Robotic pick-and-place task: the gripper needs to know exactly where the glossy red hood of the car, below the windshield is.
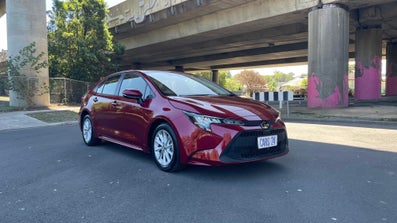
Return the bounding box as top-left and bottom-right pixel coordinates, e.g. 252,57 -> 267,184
170,96 -> 279,121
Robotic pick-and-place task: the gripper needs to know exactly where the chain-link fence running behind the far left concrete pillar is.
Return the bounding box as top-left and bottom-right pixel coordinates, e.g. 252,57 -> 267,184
0,74 -> 92,104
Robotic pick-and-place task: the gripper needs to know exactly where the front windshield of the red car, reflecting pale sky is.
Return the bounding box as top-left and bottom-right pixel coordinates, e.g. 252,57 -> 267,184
146,72 -> 233,96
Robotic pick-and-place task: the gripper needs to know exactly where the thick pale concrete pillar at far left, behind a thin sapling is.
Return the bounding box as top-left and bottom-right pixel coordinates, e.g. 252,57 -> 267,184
6,0 -> 50,107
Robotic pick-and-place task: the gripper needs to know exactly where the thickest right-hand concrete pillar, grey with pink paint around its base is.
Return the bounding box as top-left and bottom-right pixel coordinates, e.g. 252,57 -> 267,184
307,4 -> 349,108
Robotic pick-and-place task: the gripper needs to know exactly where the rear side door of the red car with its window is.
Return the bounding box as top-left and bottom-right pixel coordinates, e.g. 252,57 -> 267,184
92,74 -> 121,138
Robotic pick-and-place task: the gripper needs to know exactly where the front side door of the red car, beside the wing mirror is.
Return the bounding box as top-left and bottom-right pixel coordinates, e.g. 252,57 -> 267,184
115,72 -> 154,149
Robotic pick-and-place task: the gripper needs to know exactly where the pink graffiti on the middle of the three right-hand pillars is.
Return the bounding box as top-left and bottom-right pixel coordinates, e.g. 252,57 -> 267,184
354,56 -> 382,100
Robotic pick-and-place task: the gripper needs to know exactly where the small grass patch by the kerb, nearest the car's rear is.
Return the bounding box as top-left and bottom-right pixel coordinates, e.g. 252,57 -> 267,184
27,110 -> 79,123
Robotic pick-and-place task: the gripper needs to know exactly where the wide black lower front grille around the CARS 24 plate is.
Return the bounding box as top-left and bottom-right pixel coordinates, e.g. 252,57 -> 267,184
220,129 -> 288,163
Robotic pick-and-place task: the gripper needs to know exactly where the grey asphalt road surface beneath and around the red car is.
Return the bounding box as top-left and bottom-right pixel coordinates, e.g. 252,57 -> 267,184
0,123 -> 397,223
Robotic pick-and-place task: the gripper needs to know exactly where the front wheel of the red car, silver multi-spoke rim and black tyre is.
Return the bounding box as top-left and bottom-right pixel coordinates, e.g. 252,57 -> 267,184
152,123 -> 183,172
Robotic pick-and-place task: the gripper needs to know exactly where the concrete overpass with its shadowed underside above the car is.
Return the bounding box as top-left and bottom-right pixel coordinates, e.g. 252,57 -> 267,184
110,0 -> 397,70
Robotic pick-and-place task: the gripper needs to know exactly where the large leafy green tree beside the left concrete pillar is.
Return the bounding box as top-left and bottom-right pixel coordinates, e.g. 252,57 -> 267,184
48,0 -> 124,81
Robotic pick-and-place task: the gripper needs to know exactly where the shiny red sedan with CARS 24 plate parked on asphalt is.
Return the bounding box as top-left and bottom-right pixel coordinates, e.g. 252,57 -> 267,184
80,70 -> 288,171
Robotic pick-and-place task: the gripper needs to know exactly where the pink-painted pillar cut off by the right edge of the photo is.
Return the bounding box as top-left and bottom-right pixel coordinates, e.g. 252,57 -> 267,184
386,42 -> 397,96
